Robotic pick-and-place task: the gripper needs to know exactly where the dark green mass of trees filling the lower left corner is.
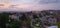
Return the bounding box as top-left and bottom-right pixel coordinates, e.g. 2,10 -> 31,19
0,13 -> 21,28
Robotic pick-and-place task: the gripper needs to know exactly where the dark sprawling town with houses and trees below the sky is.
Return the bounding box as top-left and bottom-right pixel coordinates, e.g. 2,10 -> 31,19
0,10 -> 60,28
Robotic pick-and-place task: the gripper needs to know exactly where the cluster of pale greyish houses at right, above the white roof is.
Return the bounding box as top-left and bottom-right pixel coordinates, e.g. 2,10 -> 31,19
40,16 -> 57,25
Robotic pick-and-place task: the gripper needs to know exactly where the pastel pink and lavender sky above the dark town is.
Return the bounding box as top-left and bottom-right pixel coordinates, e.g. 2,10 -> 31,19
0,0 -> 60,11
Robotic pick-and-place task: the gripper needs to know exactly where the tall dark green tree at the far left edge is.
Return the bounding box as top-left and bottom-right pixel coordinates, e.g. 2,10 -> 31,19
0,13 -> 9,28
